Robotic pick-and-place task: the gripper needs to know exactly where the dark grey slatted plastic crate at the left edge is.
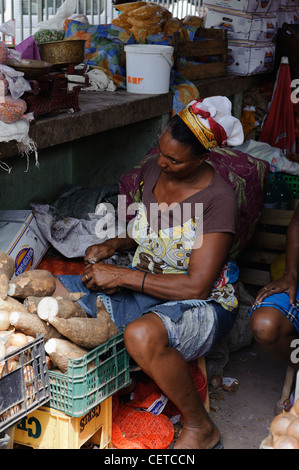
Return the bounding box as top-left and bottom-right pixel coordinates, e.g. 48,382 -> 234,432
0,335 -> 50,433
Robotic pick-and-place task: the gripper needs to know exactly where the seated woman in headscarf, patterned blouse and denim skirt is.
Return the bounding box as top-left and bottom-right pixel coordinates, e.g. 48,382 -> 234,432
56,97 -> 243,449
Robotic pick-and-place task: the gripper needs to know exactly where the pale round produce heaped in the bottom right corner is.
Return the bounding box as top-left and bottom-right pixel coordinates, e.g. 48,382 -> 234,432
260,399 -> 299,449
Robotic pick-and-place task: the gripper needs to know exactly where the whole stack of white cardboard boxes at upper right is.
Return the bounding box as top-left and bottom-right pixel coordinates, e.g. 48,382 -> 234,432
204,0 -> 279,75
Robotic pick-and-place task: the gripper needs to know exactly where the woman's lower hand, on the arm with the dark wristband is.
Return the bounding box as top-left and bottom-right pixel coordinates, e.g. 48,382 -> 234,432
81,262 -> 123,294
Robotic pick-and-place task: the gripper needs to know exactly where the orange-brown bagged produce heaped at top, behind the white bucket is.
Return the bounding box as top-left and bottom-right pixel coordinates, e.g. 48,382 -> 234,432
111,1 -> 202,43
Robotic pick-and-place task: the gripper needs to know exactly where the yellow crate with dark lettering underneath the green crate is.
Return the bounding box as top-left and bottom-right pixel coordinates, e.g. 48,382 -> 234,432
14,397 -> 112,449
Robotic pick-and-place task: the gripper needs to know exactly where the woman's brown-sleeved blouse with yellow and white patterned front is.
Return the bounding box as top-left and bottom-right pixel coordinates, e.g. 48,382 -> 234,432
131,158 -> 239,310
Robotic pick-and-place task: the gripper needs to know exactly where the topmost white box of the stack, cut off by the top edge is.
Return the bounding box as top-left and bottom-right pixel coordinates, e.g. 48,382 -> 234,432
203,0 -> 280,14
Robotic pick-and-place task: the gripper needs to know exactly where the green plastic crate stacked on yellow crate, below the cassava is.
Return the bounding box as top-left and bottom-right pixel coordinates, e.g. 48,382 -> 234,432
14,333 -> 131,449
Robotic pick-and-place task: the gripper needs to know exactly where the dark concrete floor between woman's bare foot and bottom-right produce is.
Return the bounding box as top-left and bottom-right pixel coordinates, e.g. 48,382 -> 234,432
209,341 -> 286,449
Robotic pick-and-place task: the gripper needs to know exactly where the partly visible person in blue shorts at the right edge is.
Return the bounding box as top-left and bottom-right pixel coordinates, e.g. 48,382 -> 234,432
251,206 -> 299,370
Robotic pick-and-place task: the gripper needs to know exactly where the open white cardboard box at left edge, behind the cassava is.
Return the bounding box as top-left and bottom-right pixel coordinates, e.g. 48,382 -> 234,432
0,210 -> 49,276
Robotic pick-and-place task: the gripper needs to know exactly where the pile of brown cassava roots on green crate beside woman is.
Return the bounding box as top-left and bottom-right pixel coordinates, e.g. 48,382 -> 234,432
0,251 -> 118,378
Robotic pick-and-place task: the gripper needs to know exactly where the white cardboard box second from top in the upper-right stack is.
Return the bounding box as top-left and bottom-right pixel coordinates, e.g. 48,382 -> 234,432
205,8 -> 278,43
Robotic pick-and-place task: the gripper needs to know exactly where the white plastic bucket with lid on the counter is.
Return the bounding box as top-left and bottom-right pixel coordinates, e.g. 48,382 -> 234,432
125,44 -> 173,95
